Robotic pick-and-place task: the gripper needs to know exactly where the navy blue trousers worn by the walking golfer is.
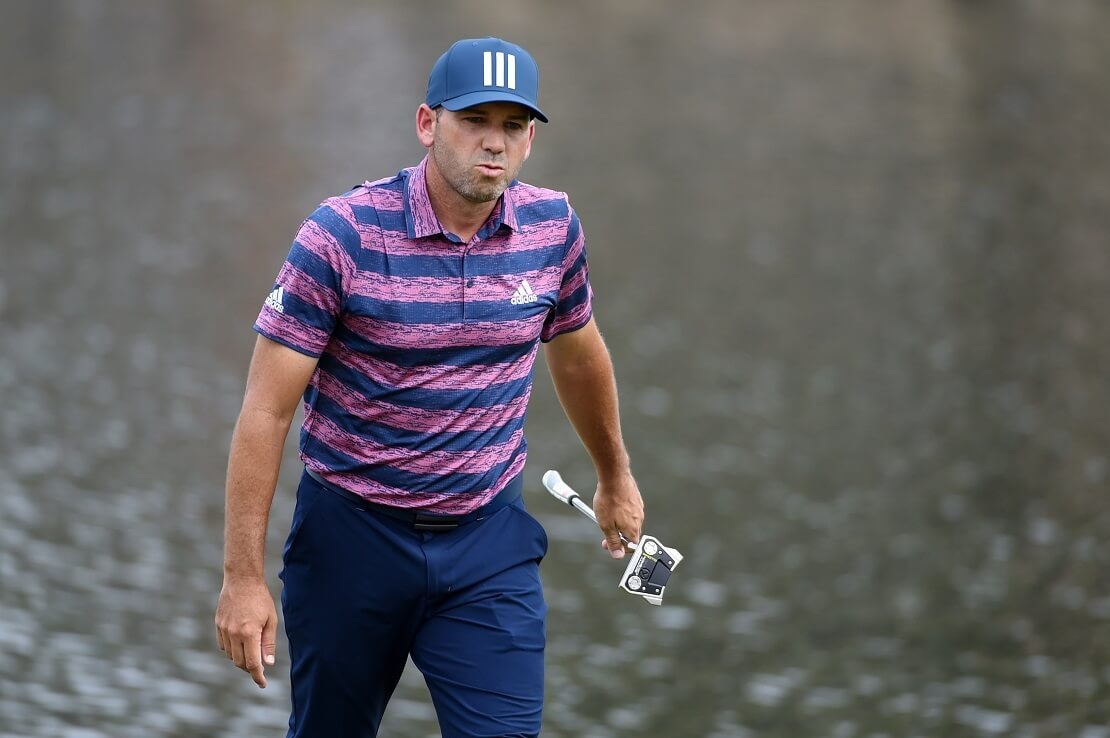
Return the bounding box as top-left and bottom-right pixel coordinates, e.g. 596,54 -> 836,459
281,474 -> 547,738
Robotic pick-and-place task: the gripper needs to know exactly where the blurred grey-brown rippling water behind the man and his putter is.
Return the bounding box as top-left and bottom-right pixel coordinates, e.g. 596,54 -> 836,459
0,0 -> 1110,738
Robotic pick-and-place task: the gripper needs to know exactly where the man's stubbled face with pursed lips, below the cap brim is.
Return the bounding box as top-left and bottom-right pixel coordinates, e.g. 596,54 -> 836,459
432,102 -> 535,203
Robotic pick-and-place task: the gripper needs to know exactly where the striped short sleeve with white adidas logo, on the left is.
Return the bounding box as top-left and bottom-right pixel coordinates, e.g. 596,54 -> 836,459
254,199 -> 361,357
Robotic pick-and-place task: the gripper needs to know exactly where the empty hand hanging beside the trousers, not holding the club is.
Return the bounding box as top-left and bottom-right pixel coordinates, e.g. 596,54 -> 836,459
215,577 -> 278,688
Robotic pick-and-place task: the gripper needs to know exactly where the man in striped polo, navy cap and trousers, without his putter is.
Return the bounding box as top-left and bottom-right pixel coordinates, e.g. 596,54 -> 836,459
215,38 -> 644,738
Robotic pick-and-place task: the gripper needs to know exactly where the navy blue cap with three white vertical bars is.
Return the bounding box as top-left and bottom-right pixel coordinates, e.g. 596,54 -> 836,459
424,38 -> 547,123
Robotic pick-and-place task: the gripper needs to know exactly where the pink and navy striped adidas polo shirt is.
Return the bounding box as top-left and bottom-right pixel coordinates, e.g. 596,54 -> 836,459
254,158 -> 592,514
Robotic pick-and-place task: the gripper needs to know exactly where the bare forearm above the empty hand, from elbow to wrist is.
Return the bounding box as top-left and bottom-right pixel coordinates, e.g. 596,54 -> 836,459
223,407 -> 291,578
